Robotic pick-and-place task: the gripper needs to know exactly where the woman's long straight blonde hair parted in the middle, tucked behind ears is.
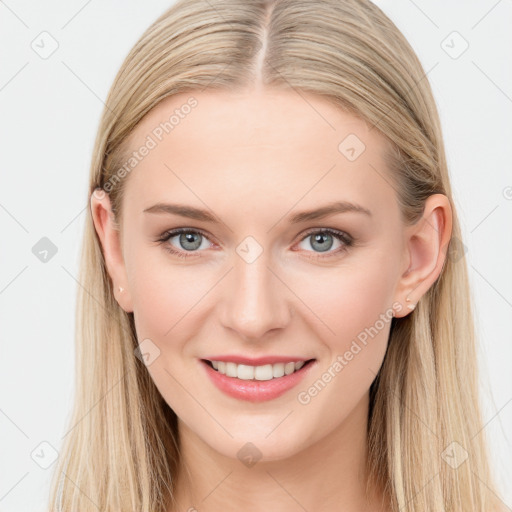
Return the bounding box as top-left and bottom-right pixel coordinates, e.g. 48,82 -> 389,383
50,0 -> 499,512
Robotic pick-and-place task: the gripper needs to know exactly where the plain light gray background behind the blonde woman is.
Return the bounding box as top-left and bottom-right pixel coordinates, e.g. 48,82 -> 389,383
0,0 -> 512,512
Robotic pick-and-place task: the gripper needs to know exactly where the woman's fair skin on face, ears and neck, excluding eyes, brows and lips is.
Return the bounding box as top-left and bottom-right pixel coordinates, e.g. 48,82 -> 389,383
91,89 -> 452,512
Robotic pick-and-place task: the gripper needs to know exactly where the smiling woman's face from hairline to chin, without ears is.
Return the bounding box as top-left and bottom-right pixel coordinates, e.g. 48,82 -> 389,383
93,91 -> 409,460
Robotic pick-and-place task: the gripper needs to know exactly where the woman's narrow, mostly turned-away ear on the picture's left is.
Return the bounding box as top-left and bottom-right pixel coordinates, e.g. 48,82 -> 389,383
91,188 -> 133,313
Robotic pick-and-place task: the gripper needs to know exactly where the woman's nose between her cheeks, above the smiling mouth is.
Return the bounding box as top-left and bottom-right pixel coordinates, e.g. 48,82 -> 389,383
220,252 -> 293,341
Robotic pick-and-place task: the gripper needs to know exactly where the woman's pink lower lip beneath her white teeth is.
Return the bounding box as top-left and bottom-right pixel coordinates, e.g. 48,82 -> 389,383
199,360 -> 316,402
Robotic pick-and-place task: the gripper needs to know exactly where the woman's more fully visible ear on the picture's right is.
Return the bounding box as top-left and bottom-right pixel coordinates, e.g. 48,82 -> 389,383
395,194 -> 452,318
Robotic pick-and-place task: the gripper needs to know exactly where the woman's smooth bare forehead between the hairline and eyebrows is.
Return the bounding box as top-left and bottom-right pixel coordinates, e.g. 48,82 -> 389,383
121,90 -> 397,225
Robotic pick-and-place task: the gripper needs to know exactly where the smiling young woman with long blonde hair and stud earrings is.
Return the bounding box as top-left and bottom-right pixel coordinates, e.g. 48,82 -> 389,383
47,0 -> 504,512
